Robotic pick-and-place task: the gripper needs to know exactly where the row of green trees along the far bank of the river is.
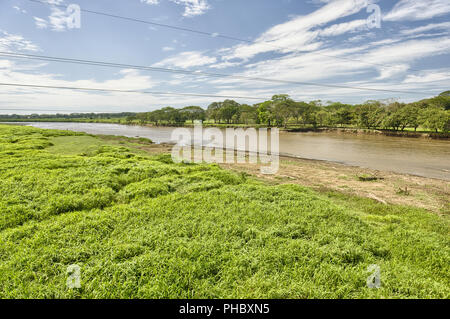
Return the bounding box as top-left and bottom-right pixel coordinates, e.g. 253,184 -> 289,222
0,91 -> 450,132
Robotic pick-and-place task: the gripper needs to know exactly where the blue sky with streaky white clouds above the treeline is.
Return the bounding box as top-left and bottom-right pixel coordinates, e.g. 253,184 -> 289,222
0,0 -> 450,114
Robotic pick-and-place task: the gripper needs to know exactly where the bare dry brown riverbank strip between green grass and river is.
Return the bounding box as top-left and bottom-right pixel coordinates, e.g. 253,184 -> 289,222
107,136 -> 450,216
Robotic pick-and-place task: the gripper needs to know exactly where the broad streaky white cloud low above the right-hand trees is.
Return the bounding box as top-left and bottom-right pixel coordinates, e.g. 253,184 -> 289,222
211,37 -> 450,99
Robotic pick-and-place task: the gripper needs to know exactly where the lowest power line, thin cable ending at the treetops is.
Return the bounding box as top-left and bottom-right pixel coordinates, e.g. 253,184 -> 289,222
0,83 -> 266,100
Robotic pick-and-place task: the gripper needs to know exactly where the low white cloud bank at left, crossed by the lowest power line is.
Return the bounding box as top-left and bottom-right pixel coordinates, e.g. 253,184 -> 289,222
0,60 -> 188,113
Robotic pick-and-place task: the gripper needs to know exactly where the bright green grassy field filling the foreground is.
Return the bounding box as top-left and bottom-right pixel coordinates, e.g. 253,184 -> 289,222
0,125 -> 450,298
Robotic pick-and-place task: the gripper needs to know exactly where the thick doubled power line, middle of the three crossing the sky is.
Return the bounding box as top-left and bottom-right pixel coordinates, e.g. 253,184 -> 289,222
0,51 -> 436,95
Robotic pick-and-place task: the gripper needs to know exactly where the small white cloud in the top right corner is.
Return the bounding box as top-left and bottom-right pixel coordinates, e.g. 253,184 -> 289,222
383,0 -> 450,21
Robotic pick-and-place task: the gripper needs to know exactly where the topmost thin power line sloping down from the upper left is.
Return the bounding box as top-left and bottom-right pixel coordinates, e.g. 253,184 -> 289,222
28,0 -> 428,72
